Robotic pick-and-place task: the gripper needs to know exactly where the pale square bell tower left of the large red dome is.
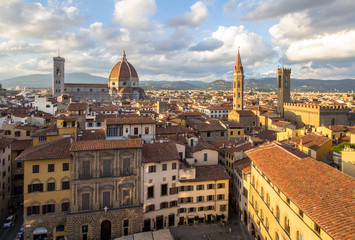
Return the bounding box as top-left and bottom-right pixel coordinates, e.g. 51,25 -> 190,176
52,56 -> 65,97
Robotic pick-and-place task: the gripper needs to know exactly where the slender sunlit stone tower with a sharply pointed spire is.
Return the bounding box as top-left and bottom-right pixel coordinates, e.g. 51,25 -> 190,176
233,49 -> 244,110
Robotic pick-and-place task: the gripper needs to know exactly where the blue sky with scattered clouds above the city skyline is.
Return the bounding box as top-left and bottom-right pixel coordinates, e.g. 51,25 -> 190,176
0,0 -> 355,81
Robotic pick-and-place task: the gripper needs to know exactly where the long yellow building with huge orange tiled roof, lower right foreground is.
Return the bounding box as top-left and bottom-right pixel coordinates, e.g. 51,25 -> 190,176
246,142 -> 355,240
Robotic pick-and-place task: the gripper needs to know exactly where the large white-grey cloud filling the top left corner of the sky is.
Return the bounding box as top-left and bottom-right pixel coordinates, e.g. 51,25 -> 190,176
0,0 -> 85,39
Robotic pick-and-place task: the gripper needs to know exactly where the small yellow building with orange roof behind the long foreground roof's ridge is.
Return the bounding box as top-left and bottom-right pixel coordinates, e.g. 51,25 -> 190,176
291,133 -> 332,161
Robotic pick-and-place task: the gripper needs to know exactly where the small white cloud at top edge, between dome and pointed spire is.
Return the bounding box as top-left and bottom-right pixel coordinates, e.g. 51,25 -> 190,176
169,1 -> 208,27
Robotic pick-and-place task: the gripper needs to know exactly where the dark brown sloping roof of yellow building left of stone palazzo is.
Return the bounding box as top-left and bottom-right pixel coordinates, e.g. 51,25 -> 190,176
16,138 -> 71,161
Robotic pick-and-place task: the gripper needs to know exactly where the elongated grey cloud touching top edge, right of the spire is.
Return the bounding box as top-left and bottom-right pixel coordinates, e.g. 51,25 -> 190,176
244,0 -> 334,21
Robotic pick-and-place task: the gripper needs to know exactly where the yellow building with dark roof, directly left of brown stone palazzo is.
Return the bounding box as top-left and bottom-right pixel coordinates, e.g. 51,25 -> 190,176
16,138 -> 70,240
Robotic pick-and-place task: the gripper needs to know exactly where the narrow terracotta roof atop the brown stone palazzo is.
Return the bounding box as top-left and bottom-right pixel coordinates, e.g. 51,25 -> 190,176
70,138 -> 143,152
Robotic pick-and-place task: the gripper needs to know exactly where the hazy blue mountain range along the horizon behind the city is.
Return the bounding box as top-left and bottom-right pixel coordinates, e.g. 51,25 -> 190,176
0,73 -> 355,92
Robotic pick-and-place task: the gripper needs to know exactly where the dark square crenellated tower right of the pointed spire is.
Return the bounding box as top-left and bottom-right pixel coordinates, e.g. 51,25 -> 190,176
276,67 -> 291,117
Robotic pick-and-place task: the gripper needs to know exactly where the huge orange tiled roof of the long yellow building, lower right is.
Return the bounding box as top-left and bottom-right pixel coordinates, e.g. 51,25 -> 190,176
246,142 -> 355,240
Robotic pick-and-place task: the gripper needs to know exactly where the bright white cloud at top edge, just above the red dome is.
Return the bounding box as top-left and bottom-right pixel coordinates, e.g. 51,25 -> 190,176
113,0 -> 157,28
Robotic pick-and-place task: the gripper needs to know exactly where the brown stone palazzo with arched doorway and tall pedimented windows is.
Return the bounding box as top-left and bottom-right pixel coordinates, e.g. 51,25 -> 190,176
67,139 -> 143,240
